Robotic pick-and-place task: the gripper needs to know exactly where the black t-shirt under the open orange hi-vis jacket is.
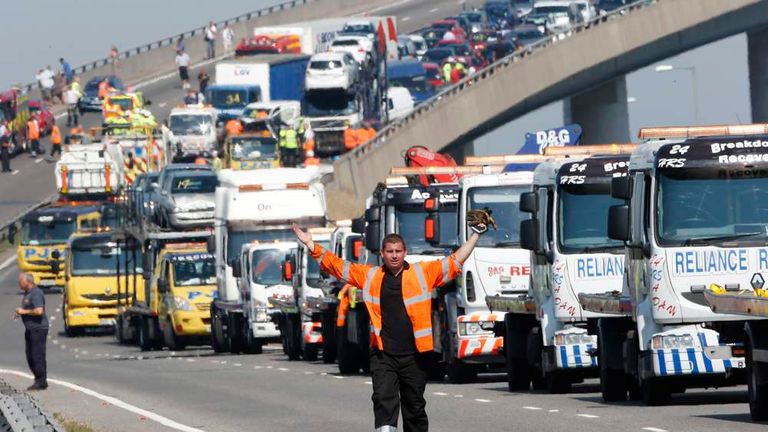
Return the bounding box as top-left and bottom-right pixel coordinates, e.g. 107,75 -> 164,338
380,263 -> 416,355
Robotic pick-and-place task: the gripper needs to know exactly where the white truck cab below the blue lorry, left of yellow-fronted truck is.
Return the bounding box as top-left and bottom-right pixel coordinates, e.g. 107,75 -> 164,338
165,105 -> 218,161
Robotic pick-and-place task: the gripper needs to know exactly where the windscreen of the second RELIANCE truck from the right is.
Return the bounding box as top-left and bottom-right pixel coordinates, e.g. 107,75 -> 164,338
557,181 -> 622,253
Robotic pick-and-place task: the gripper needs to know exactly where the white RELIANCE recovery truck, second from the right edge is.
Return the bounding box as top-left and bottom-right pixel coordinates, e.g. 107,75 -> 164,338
504,146 -> 629,393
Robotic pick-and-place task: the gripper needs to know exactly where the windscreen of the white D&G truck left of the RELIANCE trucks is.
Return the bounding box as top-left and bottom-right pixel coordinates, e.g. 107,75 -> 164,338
467,186 -> 530,247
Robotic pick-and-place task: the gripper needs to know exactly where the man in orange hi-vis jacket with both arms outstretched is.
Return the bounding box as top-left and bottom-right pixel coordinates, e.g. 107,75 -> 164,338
293,224 -> 488,432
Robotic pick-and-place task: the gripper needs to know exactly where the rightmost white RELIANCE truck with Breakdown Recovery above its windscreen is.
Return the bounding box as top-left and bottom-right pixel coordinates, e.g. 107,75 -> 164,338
583,125 -> 768,405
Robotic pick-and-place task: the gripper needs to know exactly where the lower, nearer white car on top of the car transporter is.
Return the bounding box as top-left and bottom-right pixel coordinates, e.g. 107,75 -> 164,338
304,52 -> 358,90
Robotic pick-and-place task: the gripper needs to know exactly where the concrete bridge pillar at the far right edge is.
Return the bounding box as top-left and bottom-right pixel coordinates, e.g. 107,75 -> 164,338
747,27 -> 768,123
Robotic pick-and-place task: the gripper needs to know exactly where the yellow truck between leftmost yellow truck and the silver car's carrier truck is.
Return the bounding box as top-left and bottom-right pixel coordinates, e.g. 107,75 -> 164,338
61,232 -> 144,337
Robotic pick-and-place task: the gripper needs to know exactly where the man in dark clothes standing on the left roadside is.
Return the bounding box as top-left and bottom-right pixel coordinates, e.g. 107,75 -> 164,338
14,273 -> 48,390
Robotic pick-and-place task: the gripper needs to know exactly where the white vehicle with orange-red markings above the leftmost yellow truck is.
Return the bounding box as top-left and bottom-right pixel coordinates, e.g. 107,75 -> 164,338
54,143 -> 125,197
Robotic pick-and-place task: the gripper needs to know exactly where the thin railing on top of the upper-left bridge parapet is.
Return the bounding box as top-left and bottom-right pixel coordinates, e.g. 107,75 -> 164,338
15,0 -> 318,92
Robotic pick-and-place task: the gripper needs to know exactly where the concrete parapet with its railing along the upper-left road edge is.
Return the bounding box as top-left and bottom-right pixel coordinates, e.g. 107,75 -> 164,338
19,0 -> 391,97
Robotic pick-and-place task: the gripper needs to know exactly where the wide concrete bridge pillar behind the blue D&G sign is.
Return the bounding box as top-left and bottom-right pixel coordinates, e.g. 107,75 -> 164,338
563,76 -> 630,144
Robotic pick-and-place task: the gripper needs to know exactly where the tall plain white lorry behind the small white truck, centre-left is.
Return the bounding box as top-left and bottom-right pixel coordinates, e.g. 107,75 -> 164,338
209,167 -> 326,352
